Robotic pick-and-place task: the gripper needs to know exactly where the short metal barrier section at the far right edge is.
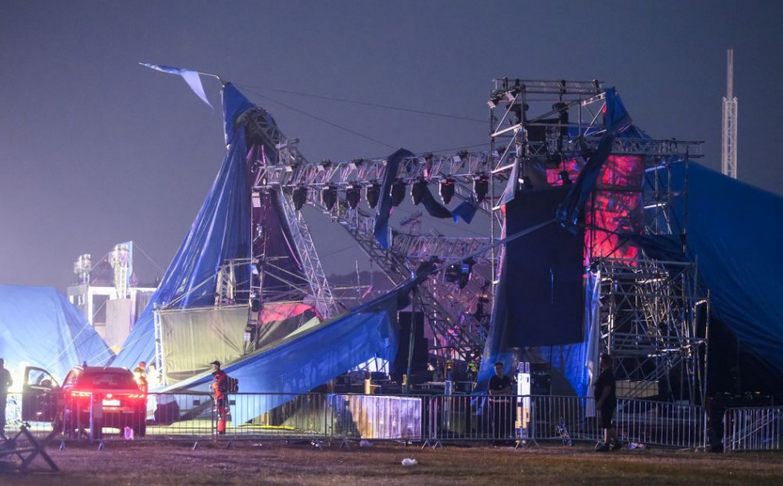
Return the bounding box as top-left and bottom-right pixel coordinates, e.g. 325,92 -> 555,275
723,407 -> 783,452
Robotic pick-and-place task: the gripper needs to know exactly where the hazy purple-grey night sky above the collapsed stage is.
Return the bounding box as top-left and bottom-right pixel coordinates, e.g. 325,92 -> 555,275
0,0 -> 783,292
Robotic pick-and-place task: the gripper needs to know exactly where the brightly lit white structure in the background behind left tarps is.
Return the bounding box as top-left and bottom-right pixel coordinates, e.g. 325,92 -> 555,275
68,241 -> 155,351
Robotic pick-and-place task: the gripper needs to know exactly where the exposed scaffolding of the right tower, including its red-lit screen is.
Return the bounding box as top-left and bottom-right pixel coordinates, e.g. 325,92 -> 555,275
488,78 -> 708,403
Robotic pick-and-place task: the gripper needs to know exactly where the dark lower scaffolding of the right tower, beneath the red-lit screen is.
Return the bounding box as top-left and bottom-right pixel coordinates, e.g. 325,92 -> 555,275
594,259 -> 707,403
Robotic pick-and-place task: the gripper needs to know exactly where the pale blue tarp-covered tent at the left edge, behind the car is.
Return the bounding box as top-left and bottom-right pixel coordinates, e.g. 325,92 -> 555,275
0,285 -> 113,385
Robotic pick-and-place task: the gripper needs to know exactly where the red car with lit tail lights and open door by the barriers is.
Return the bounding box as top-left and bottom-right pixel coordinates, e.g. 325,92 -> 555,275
22,366 -> 147,437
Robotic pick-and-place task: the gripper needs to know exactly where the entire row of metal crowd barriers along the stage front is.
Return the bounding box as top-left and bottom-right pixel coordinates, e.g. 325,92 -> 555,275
6,392 -> 712,450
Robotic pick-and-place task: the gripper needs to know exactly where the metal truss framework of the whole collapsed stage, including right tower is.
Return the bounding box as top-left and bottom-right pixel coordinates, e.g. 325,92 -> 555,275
233,78 -> 703,380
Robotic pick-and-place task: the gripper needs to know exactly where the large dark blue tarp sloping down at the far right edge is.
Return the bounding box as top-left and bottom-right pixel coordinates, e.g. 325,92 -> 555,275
643,161 -> 783,372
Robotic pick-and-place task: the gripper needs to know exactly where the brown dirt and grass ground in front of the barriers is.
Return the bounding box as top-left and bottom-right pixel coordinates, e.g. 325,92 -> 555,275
0,441 -> 783,486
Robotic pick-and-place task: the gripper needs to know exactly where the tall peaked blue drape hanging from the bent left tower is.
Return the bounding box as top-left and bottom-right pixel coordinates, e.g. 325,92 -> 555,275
114,84 -> 304,372
